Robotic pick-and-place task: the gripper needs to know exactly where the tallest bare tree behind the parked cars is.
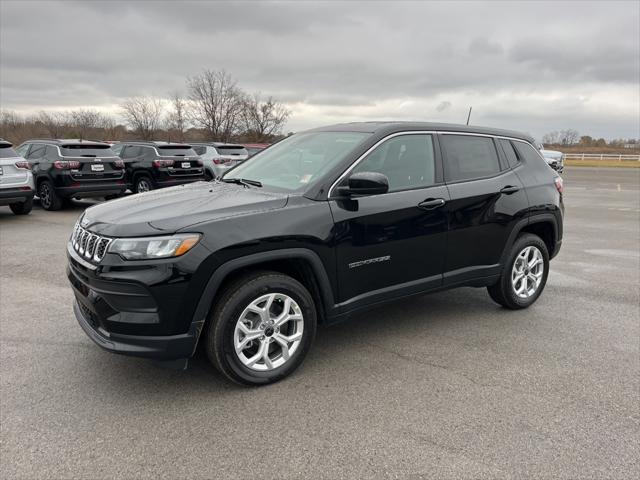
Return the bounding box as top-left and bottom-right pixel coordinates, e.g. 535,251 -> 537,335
187,70 -> 244,142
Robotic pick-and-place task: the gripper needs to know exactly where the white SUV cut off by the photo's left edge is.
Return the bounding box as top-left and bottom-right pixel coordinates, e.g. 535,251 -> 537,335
0,139 -> 35,215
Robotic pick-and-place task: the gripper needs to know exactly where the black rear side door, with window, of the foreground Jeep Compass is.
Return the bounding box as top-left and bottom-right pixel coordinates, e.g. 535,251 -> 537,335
440,134 -> 528,285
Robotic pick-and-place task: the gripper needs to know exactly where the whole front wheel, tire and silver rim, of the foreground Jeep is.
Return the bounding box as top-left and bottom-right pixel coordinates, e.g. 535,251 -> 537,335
205,272 -> 316,385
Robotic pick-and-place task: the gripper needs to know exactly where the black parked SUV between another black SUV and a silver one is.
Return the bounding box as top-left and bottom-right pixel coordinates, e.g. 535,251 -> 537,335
113,142 -> 204,193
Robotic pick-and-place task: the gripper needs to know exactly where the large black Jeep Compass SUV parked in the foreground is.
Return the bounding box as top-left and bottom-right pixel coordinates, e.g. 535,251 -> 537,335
67,123 -> 564,384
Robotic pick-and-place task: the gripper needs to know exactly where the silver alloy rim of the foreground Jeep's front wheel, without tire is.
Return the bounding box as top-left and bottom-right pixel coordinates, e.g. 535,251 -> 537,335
233,293 -> 304,372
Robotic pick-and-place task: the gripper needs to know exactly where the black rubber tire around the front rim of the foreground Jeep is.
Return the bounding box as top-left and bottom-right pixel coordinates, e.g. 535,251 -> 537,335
204,271 -> 317,386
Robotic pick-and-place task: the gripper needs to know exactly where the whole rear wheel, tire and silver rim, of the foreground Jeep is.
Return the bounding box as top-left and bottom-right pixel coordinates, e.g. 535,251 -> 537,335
487,233 -> 549,310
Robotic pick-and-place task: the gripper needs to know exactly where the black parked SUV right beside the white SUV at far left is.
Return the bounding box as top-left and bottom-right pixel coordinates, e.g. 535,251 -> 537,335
16,140 -> 127,210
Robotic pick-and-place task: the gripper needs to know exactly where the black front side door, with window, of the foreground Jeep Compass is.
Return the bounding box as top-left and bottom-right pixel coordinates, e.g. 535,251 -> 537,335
330,134 -> 449,308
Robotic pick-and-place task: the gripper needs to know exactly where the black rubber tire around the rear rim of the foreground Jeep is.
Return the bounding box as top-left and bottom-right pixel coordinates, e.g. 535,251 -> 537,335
487,233 -> 549,310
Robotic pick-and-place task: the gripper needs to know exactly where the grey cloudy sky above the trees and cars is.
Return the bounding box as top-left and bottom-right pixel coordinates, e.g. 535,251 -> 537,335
0,0 -> 640,138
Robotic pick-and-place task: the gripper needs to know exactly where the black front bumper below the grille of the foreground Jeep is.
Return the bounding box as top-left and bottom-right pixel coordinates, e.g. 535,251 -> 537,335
67,244 -> 204,360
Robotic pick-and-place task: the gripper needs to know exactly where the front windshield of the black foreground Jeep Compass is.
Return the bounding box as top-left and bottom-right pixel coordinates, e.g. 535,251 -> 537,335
223,132 -> 371,191
